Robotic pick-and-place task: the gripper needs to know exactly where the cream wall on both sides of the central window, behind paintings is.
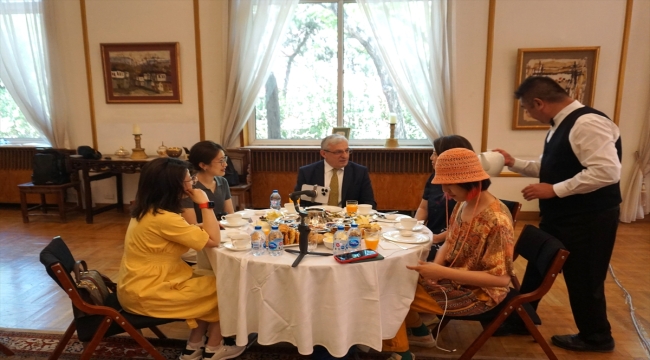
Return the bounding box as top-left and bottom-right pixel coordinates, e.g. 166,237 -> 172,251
57,0 -> 650,211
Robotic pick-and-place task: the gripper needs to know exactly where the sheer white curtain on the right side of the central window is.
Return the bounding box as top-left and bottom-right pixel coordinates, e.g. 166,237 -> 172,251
357,0 -> 454,141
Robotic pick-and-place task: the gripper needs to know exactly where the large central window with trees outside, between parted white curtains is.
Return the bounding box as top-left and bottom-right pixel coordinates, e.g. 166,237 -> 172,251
251,0 -> 428,144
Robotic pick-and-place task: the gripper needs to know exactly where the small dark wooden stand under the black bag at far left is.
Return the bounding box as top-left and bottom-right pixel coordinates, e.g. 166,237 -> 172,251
18,181 -> 82,223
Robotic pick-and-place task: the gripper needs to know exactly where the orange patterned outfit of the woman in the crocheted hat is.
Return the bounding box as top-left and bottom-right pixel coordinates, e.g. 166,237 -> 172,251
420,199 -> 514,316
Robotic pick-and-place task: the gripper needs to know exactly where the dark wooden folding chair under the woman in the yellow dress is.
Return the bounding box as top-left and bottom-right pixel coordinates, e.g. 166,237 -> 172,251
40,236 -> 180,360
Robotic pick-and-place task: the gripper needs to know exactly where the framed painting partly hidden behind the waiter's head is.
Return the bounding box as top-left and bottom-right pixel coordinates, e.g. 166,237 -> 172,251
512,46 -> 600,130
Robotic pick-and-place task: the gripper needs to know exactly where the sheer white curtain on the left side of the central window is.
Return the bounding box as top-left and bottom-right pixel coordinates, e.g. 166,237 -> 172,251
221,0 -> 299,147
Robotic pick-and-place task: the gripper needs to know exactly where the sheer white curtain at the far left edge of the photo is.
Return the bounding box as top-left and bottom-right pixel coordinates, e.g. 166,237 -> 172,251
0,0 -> 69,148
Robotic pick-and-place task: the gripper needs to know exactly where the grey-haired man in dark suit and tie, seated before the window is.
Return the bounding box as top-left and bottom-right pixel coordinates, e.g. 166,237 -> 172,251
294,134 -> 377,209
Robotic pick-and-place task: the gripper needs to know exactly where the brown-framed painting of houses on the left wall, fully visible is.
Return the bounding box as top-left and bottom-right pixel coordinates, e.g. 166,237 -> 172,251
100,42 -> 182,103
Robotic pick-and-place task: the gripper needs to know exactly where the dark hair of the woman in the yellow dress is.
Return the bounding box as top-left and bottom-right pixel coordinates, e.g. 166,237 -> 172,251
131,158 -> 190,221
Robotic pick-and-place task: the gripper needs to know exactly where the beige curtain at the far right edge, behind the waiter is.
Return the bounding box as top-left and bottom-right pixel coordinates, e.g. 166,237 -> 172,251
620,104 -> 650,223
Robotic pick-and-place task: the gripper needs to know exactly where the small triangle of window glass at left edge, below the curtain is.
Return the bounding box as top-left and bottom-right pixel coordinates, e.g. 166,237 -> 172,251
0,80 -> 43,144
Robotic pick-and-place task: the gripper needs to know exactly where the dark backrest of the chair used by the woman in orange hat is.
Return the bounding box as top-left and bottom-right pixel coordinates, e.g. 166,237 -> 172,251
515,224 -> 569,299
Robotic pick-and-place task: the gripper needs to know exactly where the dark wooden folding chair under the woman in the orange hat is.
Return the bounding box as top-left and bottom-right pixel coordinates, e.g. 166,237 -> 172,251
432,225 -> 569,360
